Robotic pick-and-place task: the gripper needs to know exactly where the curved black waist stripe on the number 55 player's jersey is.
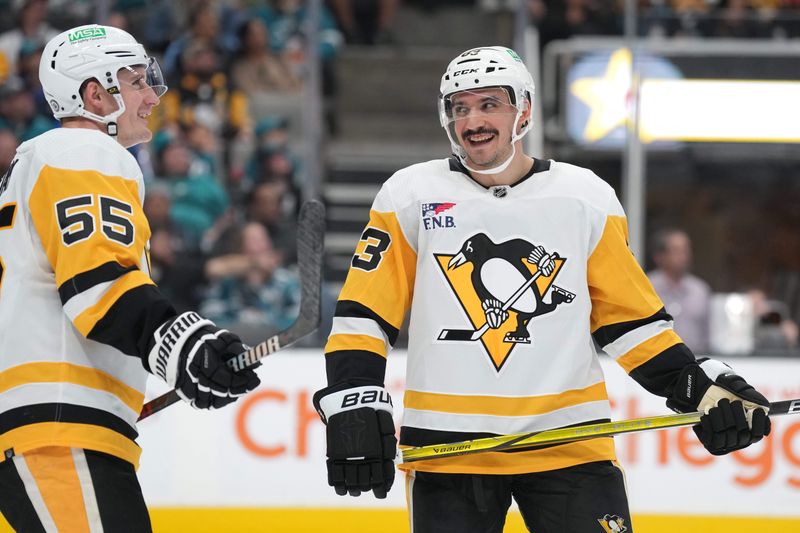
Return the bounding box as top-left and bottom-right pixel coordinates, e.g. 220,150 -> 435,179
0,403 -> 139,441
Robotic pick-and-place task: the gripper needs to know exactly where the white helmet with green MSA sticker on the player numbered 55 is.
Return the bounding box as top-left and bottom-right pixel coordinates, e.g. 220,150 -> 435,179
39,24 -> 167,135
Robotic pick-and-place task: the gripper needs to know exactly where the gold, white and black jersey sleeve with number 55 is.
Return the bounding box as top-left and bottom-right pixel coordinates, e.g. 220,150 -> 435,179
28,165 -> 175,356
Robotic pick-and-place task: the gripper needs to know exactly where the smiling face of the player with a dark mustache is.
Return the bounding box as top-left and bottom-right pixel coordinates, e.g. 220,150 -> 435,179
450,87 -> 517,169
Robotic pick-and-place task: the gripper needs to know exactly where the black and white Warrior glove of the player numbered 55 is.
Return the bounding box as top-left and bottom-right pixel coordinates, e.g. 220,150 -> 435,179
145,312 -> 261,409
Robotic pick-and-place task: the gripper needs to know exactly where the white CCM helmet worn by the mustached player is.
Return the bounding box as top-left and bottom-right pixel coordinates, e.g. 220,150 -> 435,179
439,46 -> 535,174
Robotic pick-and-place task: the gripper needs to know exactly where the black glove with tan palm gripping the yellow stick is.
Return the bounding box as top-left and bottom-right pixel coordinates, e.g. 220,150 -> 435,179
667,358 -> 771,455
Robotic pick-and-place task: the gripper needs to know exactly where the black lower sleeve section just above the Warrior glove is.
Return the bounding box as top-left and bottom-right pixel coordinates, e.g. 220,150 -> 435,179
88,285 -> 178,360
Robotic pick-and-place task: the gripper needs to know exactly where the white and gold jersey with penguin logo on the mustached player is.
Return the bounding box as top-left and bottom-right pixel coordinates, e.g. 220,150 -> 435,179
325,159 -> 694,474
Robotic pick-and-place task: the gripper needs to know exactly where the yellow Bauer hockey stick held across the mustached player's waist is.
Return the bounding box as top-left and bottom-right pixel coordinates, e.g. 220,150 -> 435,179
402,398 -> 800,463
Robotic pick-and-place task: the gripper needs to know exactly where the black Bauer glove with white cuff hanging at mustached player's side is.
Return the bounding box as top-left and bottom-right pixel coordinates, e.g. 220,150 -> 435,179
314,380 -> 397,498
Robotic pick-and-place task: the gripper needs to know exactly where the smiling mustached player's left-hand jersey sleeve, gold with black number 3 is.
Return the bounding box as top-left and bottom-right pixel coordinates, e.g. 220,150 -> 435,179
325,182 -> 417,384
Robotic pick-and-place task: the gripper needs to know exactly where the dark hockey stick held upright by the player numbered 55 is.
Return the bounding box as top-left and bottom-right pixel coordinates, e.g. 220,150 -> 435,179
139,200 -> 325,420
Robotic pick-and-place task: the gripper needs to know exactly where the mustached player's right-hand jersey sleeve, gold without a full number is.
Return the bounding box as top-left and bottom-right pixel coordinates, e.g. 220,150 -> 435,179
587,193 -> 695,396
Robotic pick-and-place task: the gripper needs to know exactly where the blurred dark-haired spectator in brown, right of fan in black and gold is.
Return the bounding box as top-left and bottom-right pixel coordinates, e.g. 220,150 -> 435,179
231,18 -> 302,95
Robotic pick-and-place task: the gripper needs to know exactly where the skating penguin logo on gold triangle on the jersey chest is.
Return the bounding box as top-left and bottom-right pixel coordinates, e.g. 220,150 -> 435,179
434,233 -> 575,371
